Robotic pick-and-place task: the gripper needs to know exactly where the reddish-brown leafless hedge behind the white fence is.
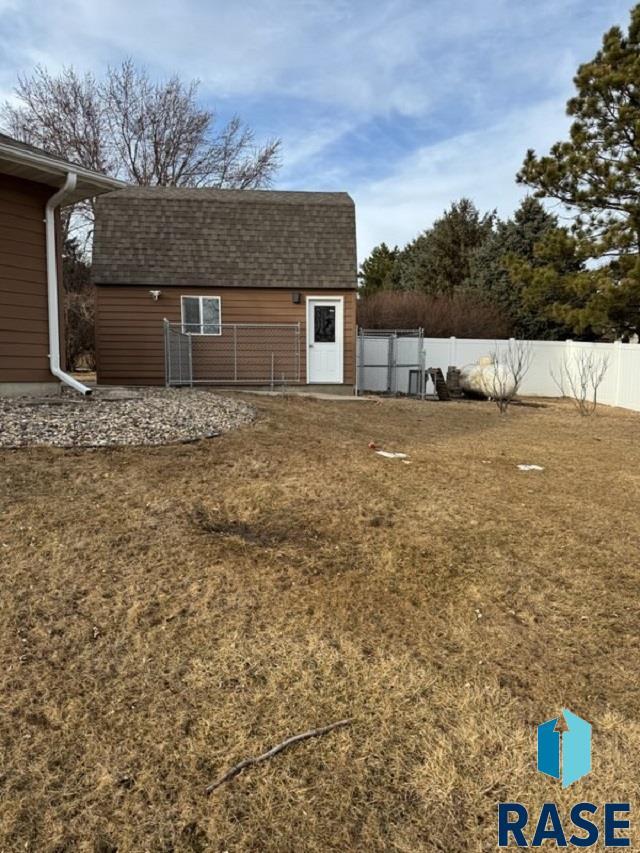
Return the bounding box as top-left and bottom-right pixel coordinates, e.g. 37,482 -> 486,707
358,290 -> 512,339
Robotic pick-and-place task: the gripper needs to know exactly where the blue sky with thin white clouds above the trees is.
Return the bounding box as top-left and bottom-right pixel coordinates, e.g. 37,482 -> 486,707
0,0 -> 632,258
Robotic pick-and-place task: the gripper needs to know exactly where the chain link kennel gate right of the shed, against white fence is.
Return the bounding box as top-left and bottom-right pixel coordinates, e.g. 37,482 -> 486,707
356,328 -> 426,398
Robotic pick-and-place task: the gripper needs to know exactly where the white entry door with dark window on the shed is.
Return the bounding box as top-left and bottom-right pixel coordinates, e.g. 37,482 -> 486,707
307,296 -> 344,383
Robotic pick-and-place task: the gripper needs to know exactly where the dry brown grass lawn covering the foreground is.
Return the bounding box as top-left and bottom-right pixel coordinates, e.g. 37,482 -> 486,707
0,399 -> 640,853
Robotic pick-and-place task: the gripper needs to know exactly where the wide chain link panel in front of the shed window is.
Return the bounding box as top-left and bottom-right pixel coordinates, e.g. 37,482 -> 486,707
164,320 -> 301,388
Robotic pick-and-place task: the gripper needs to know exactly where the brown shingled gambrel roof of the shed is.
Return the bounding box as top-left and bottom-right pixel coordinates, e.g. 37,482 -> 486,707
93,187 -> 356,289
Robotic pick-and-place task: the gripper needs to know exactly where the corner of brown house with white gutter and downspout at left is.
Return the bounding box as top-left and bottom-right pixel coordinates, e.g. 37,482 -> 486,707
0,134 -> 123,394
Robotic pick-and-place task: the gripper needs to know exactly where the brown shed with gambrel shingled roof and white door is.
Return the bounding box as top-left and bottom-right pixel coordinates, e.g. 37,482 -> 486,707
92,187 -> 357,387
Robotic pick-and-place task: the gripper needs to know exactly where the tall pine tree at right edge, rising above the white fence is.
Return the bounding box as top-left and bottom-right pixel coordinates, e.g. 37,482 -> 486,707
518,4 -> 640,337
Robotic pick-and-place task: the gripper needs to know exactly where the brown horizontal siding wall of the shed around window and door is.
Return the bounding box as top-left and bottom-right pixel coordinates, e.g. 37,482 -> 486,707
96,285 -> 356,385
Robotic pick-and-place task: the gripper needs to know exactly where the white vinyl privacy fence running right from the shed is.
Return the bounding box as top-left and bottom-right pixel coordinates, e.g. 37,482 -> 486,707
358,337 -> 640,411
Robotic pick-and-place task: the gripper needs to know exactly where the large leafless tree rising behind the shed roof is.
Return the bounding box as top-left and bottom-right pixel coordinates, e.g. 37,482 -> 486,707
0,59 -> 280,195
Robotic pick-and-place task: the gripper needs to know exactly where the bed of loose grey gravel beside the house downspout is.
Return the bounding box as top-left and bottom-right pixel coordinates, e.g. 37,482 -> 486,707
0,388 -> 255,448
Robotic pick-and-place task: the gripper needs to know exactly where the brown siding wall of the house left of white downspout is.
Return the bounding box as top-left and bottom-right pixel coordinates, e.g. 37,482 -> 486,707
0,175 -> 62,385
